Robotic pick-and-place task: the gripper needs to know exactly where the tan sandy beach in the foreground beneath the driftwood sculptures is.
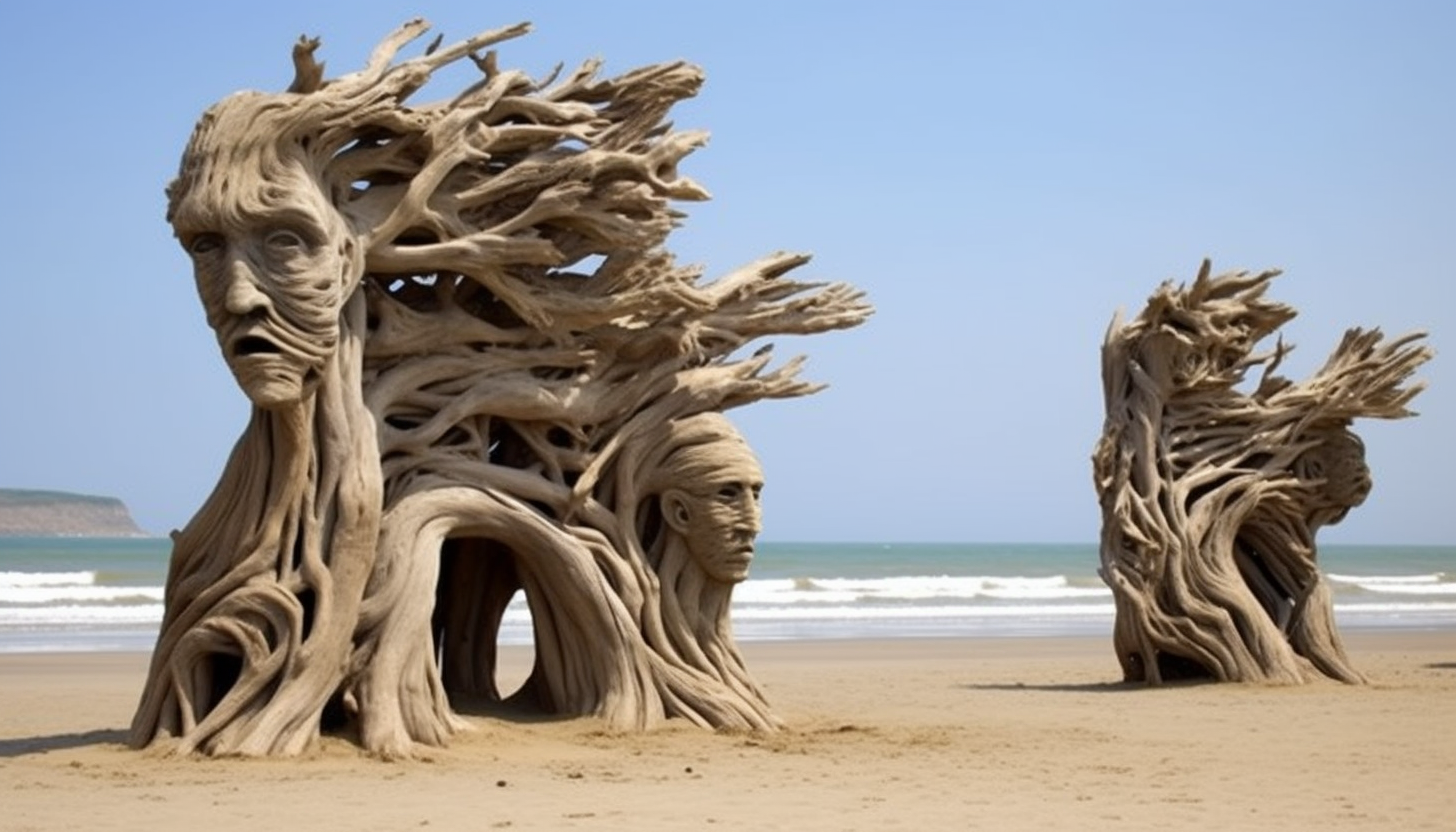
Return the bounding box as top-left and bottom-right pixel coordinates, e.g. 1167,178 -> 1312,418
0,631 -> 1456,832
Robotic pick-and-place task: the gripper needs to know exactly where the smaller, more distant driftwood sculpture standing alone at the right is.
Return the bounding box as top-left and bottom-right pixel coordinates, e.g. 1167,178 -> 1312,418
1093,261 -> 1431,683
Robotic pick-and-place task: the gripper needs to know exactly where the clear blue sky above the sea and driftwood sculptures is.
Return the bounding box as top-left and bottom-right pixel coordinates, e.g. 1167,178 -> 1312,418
0,0 -> 1456,543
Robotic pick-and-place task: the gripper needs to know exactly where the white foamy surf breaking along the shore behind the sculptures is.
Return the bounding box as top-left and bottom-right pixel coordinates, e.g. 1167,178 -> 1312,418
0,562 -> 1456,651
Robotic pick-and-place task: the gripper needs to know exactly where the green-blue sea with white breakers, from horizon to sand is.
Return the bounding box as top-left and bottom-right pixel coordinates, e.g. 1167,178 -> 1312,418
0,538 -> 1456,653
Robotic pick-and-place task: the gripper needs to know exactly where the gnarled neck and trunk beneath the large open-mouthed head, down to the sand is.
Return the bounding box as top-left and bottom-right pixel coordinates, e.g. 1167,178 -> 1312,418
132,292 -> 381,755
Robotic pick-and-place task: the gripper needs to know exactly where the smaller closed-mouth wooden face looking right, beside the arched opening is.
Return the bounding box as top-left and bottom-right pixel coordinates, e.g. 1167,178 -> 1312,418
660,412 -> 763,583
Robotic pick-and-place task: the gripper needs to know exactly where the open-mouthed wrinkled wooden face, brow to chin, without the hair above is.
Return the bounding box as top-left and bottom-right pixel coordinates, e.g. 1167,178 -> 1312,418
172,168 -> 357,408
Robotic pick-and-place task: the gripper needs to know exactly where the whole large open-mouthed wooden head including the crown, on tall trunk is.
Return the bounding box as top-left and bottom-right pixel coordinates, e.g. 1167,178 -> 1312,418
169,95 -> 363,408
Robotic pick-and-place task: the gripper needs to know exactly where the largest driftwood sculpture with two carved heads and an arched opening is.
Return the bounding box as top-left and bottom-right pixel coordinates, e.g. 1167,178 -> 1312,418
131,20 -> 871,756
